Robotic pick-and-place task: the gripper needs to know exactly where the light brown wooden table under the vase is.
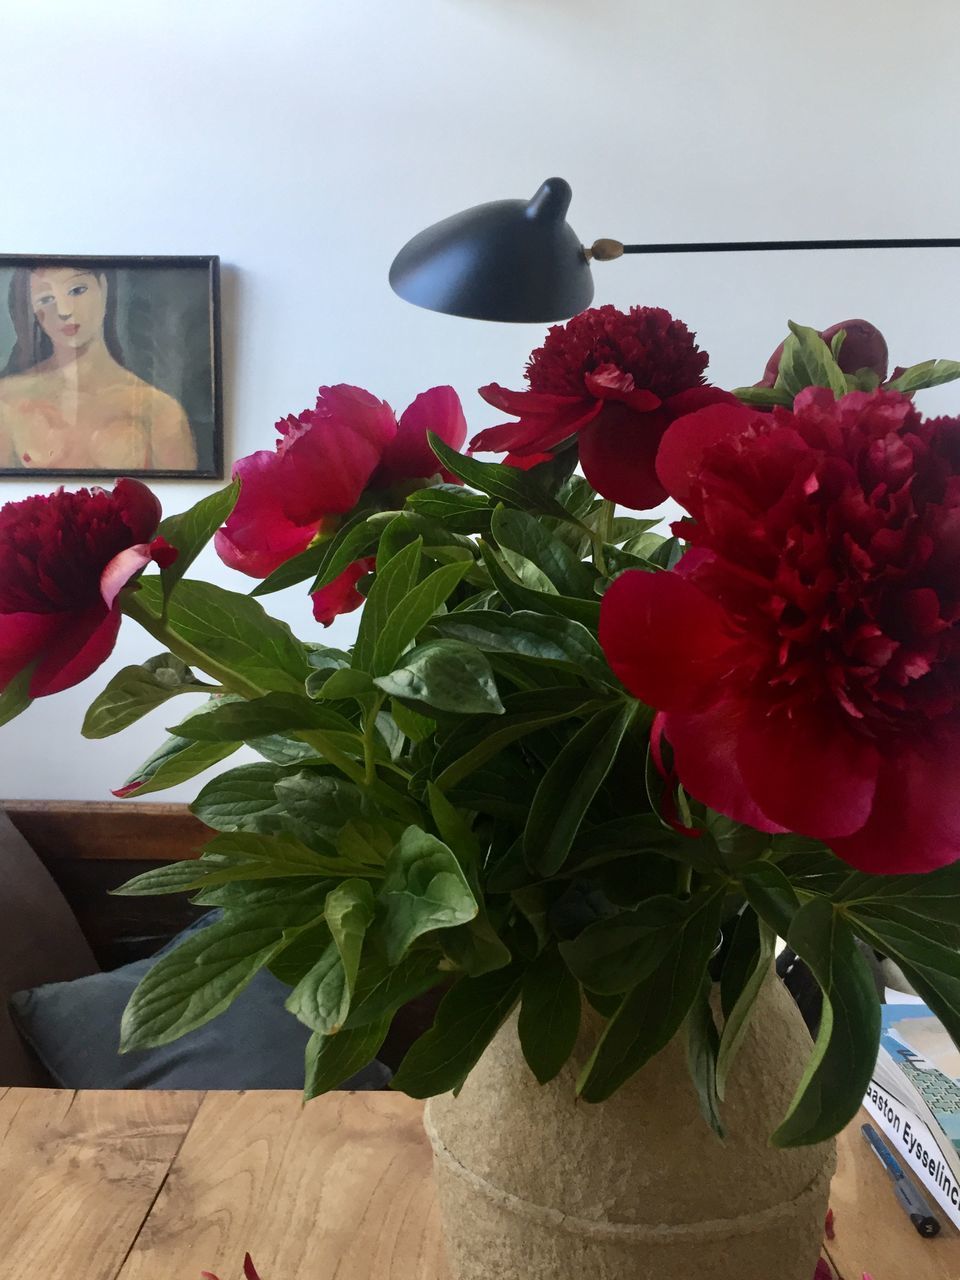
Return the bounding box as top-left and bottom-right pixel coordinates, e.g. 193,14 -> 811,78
0,1088 -> 960,1280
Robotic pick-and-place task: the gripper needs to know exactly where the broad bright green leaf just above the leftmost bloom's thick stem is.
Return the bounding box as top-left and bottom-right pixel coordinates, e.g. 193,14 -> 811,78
137,577 -> 310,694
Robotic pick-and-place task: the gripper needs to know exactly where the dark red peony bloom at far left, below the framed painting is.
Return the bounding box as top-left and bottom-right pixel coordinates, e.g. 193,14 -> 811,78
0,480 -> 177,698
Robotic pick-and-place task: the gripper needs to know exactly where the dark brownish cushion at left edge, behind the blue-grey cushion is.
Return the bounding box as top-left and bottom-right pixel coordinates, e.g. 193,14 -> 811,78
0,810 -> 97,1088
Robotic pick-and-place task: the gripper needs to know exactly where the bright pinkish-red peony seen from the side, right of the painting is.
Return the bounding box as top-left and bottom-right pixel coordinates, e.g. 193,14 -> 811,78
221,385 -> 467,577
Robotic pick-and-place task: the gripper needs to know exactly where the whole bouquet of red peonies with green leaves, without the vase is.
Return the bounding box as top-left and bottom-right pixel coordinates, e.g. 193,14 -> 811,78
0,307 -> 960,1146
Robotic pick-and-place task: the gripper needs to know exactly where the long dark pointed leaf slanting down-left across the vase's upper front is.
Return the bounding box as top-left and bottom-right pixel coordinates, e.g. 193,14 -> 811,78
577,892 -> 722,1102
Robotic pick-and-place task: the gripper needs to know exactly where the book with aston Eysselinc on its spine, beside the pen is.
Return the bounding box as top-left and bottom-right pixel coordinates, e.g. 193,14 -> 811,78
864,1002 -> 960,1228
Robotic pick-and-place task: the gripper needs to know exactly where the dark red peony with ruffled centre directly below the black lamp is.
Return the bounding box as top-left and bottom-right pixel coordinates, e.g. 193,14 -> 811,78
470,306 -> 737,511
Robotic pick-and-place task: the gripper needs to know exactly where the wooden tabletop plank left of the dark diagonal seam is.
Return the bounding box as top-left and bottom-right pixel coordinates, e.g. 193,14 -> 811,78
0,1088 -> 202,1280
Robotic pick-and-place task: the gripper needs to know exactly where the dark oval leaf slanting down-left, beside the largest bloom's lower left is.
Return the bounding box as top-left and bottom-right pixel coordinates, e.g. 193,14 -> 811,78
524,703 -> 639,876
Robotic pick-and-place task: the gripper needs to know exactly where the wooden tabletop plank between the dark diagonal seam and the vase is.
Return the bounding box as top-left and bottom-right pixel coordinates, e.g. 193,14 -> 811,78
118,1093 -> 445,1280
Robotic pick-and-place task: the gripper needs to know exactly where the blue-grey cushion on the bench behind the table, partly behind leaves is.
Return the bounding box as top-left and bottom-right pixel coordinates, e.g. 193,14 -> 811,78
10,911 -> 390,1089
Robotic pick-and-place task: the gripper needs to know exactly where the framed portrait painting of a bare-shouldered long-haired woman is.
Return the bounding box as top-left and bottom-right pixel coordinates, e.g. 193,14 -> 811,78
0,255 -> 223,479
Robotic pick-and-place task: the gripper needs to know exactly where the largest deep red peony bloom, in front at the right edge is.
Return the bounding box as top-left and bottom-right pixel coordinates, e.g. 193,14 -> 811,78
600,388 -> 960,872
